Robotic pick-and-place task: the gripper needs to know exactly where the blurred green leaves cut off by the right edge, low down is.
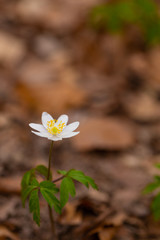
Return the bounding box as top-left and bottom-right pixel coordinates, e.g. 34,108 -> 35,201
143,163 -> 160,220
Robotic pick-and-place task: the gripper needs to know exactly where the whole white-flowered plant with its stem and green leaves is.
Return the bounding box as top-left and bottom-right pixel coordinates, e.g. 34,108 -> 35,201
21,112 -> 98,231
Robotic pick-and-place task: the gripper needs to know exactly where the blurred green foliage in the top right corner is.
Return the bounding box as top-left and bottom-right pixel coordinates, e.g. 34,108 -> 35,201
90,0 -> 160,44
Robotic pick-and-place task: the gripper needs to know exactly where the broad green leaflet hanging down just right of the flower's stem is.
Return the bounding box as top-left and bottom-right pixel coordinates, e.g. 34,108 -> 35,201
60,177 -> 76,207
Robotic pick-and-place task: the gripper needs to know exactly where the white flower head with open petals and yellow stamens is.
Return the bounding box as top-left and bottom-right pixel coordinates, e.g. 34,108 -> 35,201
29,112 -> 79,141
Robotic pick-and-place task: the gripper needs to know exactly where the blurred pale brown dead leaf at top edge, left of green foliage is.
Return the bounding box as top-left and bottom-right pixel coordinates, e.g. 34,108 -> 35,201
16,0 -> 101,33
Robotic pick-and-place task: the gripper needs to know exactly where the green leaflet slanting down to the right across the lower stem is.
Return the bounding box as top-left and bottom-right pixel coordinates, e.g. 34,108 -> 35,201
40,188 -> 61,213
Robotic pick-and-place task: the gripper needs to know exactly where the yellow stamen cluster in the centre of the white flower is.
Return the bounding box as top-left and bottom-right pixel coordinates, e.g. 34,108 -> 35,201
47,120 -> 65,135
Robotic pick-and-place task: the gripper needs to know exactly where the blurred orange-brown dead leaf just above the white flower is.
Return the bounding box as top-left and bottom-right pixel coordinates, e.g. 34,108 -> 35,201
17,82 -> 86,115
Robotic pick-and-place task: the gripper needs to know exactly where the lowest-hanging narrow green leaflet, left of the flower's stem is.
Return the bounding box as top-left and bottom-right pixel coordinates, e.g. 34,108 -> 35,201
29,189 -> 40,226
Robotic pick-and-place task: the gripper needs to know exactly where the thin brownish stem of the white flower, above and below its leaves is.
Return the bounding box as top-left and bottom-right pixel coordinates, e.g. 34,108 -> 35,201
47,141 -> 57,240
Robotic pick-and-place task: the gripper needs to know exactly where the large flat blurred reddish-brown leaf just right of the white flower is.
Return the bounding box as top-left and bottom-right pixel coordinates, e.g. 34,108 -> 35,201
73,117 -> 135,151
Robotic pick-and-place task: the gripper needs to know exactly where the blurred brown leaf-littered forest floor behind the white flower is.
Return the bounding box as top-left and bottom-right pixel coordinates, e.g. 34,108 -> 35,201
0,0 -> 160,240
